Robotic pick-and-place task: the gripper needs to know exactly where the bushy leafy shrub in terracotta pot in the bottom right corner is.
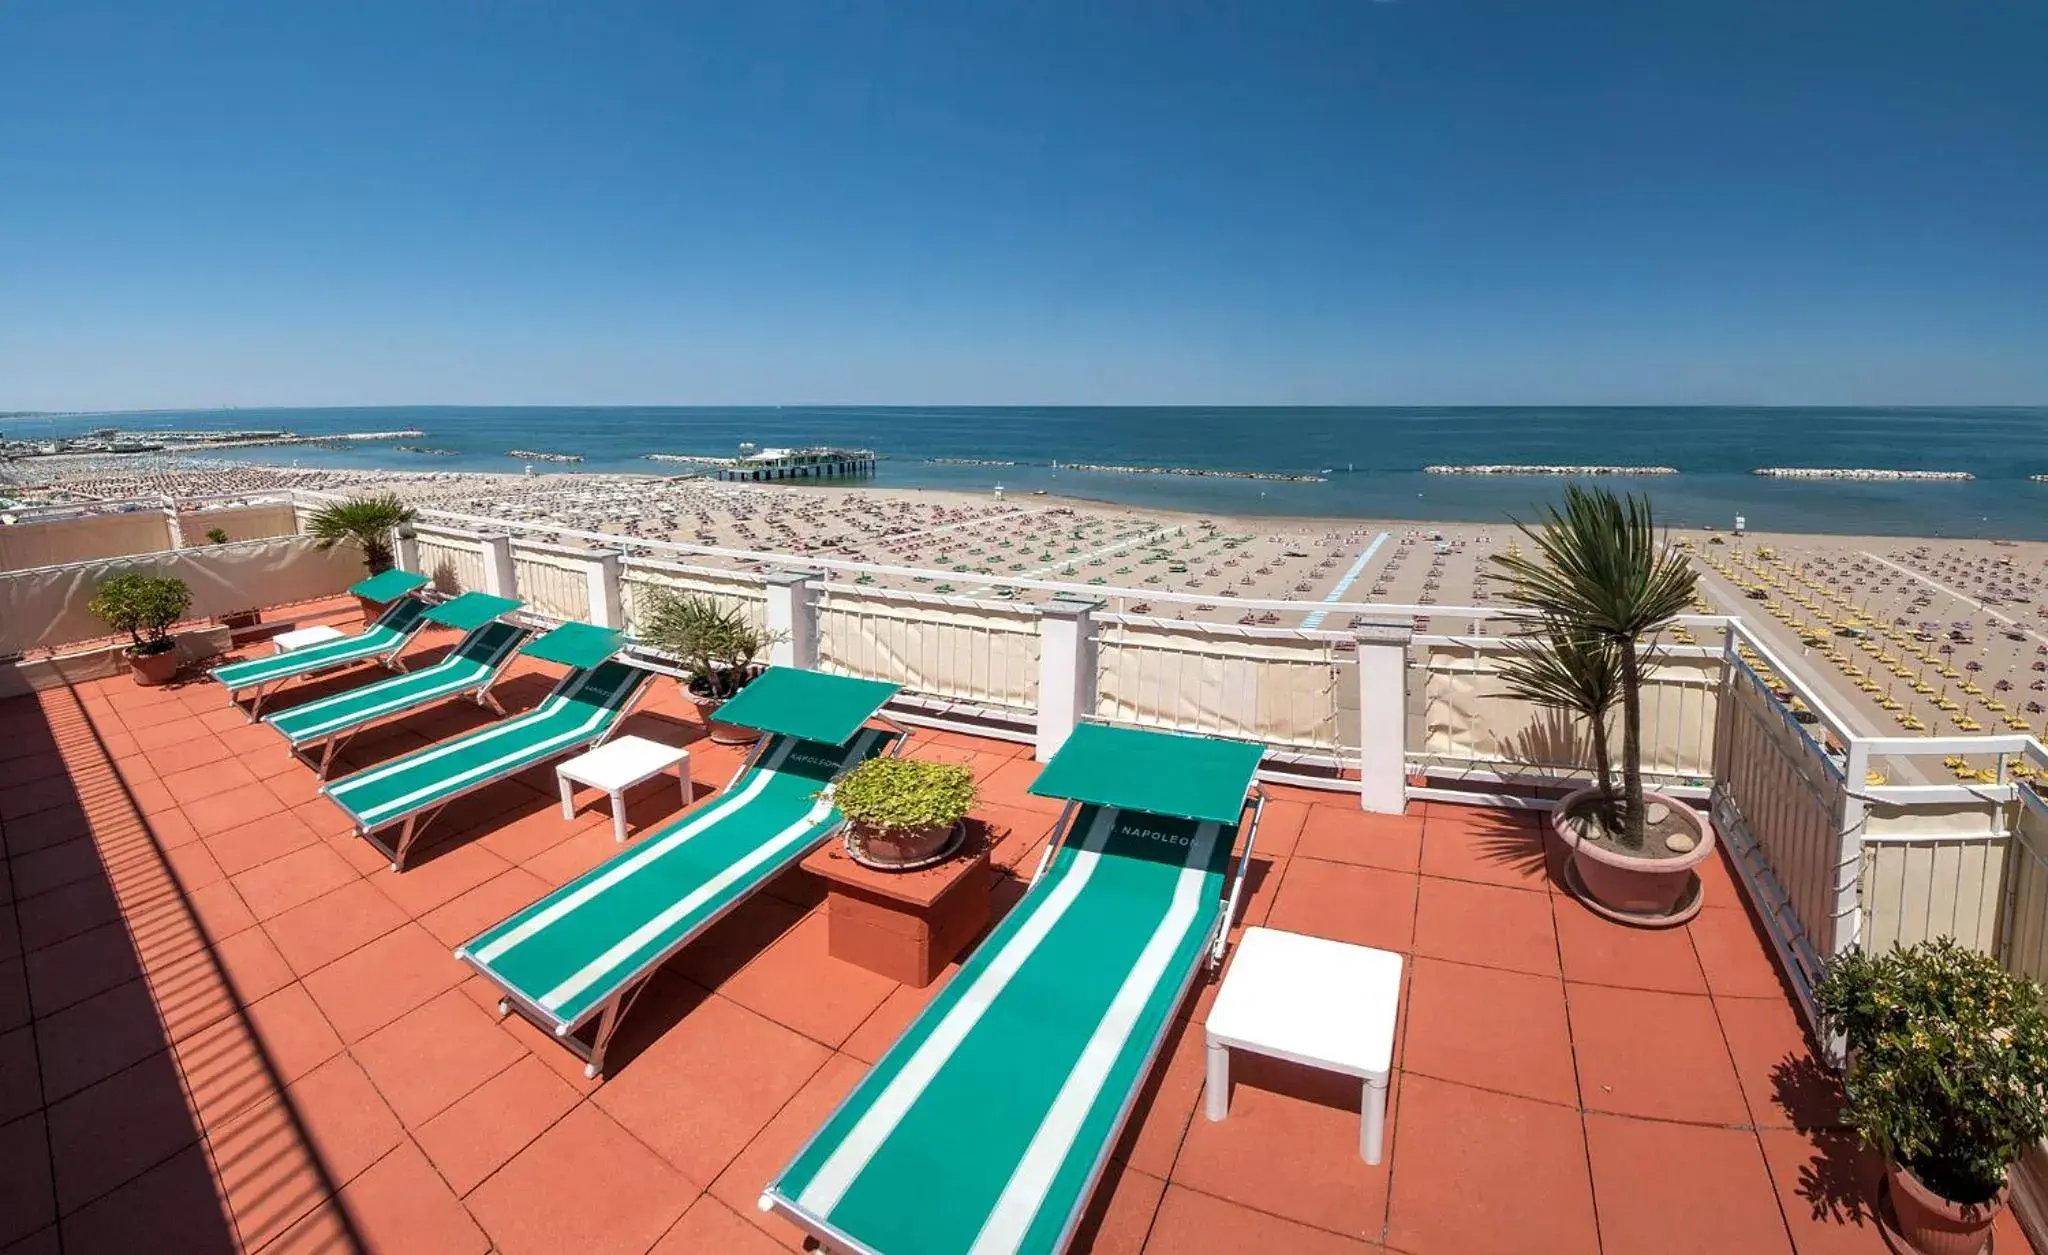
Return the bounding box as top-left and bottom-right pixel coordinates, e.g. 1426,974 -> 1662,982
1815,938 -> 2048,1255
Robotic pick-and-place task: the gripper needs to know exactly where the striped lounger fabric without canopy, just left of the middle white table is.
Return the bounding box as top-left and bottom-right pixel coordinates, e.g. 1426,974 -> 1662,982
319,661 -> 651,831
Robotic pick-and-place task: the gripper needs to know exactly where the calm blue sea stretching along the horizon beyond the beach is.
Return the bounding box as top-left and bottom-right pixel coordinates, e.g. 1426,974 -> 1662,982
0,405 -> 2048,538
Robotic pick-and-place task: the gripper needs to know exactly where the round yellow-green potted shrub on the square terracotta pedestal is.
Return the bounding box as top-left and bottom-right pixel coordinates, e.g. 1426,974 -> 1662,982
831,758 -> 975,872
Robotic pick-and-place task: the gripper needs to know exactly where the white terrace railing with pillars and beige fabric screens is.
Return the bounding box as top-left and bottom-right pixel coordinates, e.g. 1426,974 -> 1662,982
16,493 -> 2048,1027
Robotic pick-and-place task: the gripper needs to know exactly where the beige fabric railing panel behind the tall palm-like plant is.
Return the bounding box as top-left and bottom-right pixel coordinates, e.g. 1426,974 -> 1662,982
1421,643 -> 1722,780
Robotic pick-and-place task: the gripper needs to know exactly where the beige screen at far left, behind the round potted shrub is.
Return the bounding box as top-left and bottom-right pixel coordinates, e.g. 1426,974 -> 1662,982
0,536 -> 362,653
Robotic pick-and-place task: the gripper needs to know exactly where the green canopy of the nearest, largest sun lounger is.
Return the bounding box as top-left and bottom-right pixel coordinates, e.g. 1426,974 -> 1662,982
1040,712 -> 1264,823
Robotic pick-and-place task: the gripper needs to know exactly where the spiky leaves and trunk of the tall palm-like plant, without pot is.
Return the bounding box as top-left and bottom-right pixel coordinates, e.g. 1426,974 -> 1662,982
1493,485 -> 1700,850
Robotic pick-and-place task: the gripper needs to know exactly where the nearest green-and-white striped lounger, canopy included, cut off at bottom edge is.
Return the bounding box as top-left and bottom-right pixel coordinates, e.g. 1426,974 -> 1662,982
760,725 -> 1260,1255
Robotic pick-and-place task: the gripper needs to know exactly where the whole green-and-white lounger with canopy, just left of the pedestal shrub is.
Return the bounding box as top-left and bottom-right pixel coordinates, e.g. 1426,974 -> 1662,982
455,667 -> 903,1077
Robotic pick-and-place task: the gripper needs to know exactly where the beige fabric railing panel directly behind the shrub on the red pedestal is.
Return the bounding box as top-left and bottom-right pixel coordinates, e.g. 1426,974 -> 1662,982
817,583 -> 1042,710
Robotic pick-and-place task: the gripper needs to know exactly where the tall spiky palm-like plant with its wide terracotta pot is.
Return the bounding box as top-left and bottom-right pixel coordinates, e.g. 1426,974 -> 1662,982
1493,485 -> 1714,925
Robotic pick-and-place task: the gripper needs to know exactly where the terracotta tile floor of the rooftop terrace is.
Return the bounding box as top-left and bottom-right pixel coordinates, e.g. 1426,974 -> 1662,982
0,612 -> 2023,1255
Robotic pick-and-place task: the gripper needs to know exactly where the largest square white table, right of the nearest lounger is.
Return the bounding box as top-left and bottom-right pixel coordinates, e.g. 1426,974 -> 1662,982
1204,927 -> 1401,1163
